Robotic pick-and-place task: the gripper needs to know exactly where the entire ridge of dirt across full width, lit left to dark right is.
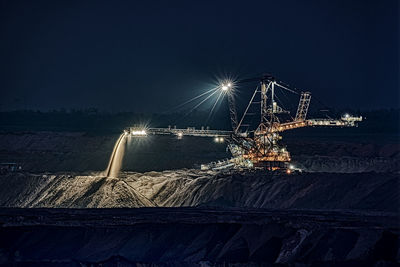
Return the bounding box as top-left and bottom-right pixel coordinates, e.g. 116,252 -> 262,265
0,170 -> 399,211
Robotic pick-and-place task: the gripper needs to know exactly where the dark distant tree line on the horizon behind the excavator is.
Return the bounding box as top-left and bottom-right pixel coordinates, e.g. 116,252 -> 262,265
0,108 -> 400,133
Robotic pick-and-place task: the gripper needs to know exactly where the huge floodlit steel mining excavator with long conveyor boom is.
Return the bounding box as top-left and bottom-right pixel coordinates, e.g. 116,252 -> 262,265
126,75 -> 362,171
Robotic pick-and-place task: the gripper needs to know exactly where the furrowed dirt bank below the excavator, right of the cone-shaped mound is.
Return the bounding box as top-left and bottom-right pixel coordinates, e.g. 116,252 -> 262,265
130,171 -> 399,211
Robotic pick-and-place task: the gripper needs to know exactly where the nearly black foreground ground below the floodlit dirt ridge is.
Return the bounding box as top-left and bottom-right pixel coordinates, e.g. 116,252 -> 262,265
0,208 -> 400,266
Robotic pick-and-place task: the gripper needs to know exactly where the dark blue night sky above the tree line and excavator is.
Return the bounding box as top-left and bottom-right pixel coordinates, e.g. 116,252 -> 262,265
0,0 -> 399,112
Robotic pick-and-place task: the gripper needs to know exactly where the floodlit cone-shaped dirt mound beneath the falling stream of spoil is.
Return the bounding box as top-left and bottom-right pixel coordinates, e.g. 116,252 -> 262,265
0,174 -> 155,208
